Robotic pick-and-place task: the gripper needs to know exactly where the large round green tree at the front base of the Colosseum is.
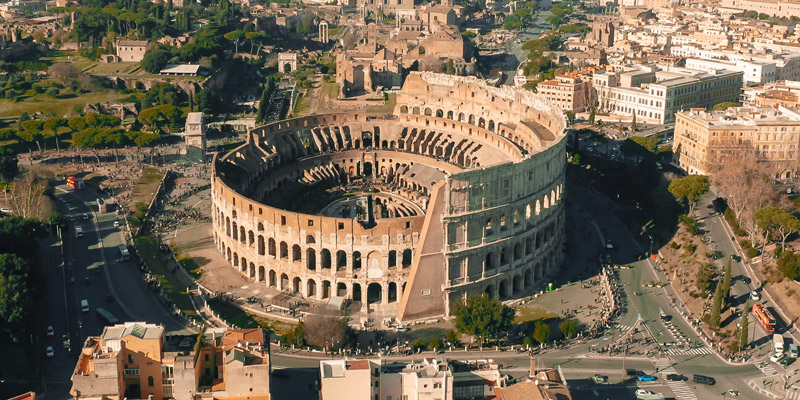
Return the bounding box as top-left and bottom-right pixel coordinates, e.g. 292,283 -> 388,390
453,294 -> 514,344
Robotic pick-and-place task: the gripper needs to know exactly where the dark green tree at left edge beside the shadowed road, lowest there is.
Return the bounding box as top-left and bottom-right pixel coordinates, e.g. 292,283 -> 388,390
0,254 -> 32,339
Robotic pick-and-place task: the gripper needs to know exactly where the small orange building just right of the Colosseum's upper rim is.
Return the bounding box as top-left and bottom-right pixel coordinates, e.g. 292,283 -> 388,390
536,71 -> 594,112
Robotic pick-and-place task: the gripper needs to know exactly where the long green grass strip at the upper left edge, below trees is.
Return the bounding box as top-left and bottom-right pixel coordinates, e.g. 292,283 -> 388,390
0,90 -> 131,118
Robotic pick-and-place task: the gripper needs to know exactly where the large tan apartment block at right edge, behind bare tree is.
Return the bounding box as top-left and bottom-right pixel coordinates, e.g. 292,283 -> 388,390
673,107 -> 800,179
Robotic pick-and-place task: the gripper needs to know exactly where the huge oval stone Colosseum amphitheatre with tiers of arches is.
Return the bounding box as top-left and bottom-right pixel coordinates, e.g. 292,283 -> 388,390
212,72 -> 566,322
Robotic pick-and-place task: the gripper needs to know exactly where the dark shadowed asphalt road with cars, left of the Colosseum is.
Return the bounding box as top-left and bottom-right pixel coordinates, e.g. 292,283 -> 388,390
42,185 -> 190,398
